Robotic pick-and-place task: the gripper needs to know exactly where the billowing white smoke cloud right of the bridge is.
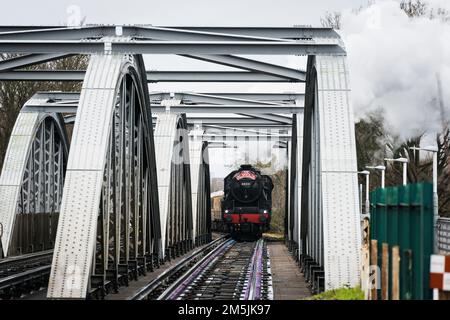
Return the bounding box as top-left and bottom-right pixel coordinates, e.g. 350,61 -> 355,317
342,0 -> 450,138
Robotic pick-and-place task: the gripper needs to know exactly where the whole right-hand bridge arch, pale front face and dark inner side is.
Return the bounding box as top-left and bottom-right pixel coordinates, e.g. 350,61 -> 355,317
291,56 -> 361,289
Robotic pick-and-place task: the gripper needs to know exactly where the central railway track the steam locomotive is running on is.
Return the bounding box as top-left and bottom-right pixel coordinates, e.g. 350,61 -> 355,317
141,239 -> 273,300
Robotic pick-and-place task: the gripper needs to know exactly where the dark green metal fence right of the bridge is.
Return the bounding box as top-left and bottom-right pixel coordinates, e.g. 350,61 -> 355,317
370,183 -> 433,300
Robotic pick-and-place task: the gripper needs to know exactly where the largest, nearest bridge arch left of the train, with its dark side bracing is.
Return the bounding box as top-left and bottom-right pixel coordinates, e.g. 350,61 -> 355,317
47,54 -> 161,298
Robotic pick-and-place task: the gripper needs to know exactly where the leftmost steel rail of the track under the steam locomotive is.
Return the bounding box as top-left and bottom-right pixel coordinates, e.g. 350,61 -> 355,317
127,235 -> 228,300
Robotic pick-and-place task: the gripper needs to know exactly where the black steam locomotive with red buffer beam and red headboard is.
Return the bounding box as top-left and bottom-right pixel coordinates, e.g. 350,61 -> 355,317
221,165 -> 273,238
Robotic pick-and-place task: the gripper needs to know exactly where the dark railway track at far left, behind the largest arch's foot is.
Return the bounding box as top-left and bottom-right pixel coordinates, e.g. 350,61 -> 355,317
0,250 -> 53,299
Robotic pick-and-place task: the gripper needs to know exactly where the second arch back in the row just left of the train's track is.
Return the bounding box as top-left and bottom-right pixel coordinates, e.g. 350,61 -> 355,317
154,112 -> 193,260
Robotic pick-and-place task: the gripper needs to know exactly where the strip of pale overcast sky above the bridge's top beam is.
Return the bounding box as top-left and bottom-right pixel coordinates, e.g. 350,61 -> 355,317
0,0 -> 367,26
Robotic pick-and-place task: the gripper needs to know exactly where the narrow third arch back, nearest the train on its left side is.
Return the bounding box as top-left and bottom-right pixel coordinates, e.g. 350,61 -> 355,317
189,130 -> 211,246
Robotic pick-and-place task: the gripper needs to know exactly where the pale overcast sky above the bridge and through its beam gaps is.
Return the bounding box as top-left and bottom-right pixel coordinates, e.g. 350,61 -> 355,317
0,0 -> 412,177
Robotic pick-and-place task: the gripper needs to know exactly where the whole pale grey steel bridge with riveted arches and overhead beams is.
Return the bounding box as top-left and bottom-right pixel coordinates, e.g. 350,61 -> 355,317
0,25 -> 361,298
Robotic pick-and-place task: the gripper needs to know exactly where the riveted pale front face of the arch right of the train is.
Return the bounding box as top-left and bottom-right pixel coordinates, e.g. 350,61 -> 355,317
315,57 -> 361,289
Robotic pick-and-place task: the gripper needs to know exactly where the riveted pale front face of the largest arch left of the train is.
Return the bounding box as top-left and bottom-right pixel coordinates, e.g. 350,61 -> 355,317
47,54 -> 127,298
